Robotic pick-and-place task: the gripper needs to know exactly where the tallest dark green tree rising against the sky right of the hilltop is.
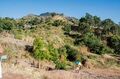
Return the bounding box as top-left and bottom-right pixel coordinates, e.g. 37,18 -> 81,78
78,13 -> 101,34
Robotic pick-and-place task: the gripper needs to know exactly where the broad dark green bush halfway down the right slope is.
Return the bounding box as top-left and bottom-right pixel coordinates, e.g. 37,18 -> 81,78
76,33 -> 113,55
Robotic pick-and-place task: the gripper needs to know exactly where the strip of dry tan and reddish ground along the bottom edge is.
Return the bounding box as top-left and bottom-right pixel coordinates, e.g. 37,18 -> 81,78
3,60 -> 120,79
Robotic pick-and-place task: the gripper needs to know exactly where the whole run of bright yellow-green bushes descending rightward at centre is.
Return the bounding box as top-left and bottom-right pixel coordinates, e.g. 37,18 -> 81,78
33,38 -> 66,69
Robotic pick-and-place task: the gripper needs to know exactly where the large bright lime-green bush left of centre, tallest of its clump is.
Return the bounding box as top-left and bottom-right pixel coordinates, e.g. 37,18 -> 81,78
33,38 -> 59,61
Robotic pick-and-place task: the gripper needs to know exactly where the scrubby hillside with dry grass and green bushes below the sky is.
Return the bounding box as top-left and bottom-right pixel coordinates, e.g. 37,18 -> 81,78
0,12 -> 120,79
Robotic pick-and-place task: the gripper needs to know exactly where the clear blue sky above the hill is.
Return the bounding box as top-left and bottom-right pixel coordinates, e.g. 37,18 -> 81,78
0,0 -> 120,22
